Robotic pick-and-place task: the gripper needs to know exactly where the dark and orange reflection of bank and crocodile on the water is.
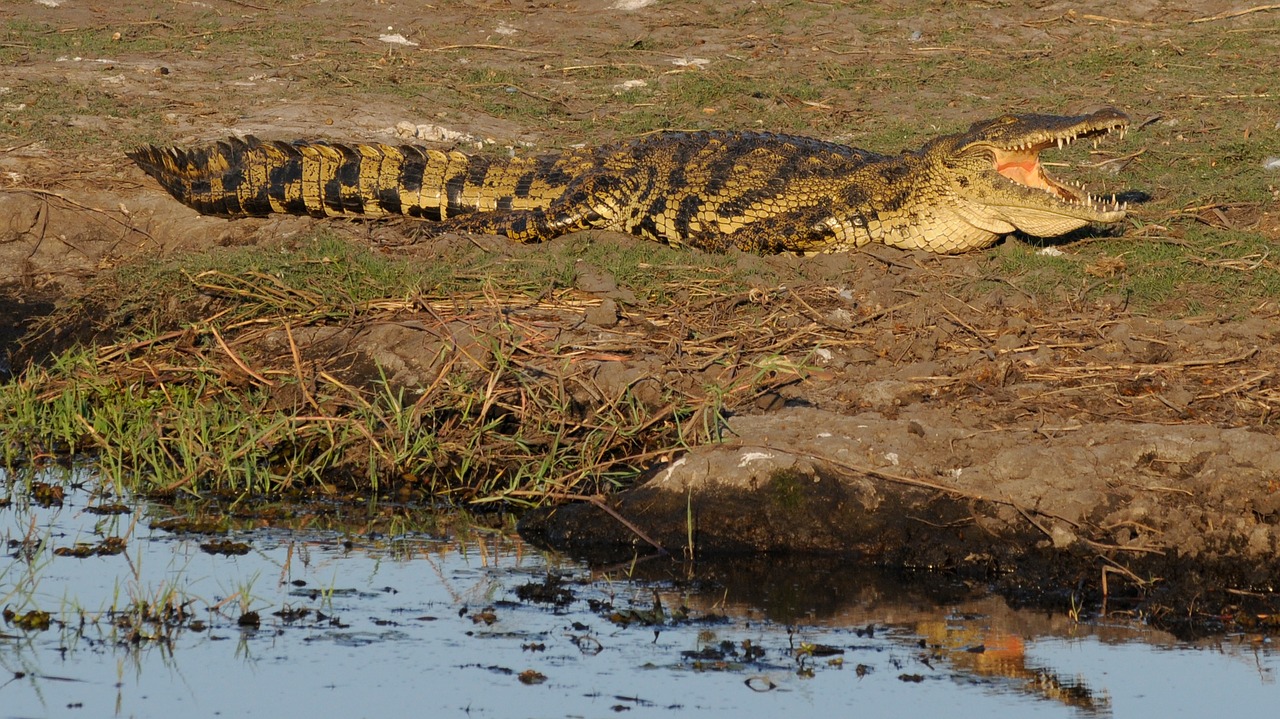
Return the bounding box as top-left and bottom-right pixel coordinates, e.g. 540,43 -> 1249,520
593,557 -> 1116,716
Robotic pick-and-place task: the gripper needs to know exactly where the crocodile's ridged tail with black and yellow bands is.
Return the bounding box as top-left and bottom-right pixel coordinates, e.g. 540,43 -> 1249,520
128,137 -> 509,220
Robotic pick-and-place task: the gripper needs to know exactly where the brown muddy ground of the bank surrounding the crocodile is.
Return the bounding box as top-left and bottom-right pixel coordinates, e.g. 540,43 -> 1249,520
0,0 -> 1280,624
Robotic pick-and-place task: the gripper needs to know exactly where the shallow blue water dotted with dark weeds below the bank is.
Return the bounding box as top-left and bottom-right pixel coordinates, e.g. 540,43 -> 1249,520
0,468 -> 1280,716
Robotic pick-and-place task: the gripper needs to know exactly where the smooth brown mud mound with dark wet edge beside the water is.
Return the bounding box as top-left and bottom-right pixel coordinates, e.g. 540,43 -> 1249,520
522,408 -> 1280,614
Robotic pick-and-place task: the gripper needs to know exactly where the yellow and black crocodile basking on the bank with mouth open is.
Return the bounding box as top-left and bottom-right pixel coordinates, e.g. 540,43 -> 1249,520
128,107 -> 1129,255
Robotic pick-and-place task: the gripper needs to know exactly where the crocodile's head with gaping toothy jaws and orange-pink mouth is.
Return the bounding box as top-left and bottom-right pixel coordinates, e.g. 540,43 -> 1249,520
924,107 -> 1129,248
